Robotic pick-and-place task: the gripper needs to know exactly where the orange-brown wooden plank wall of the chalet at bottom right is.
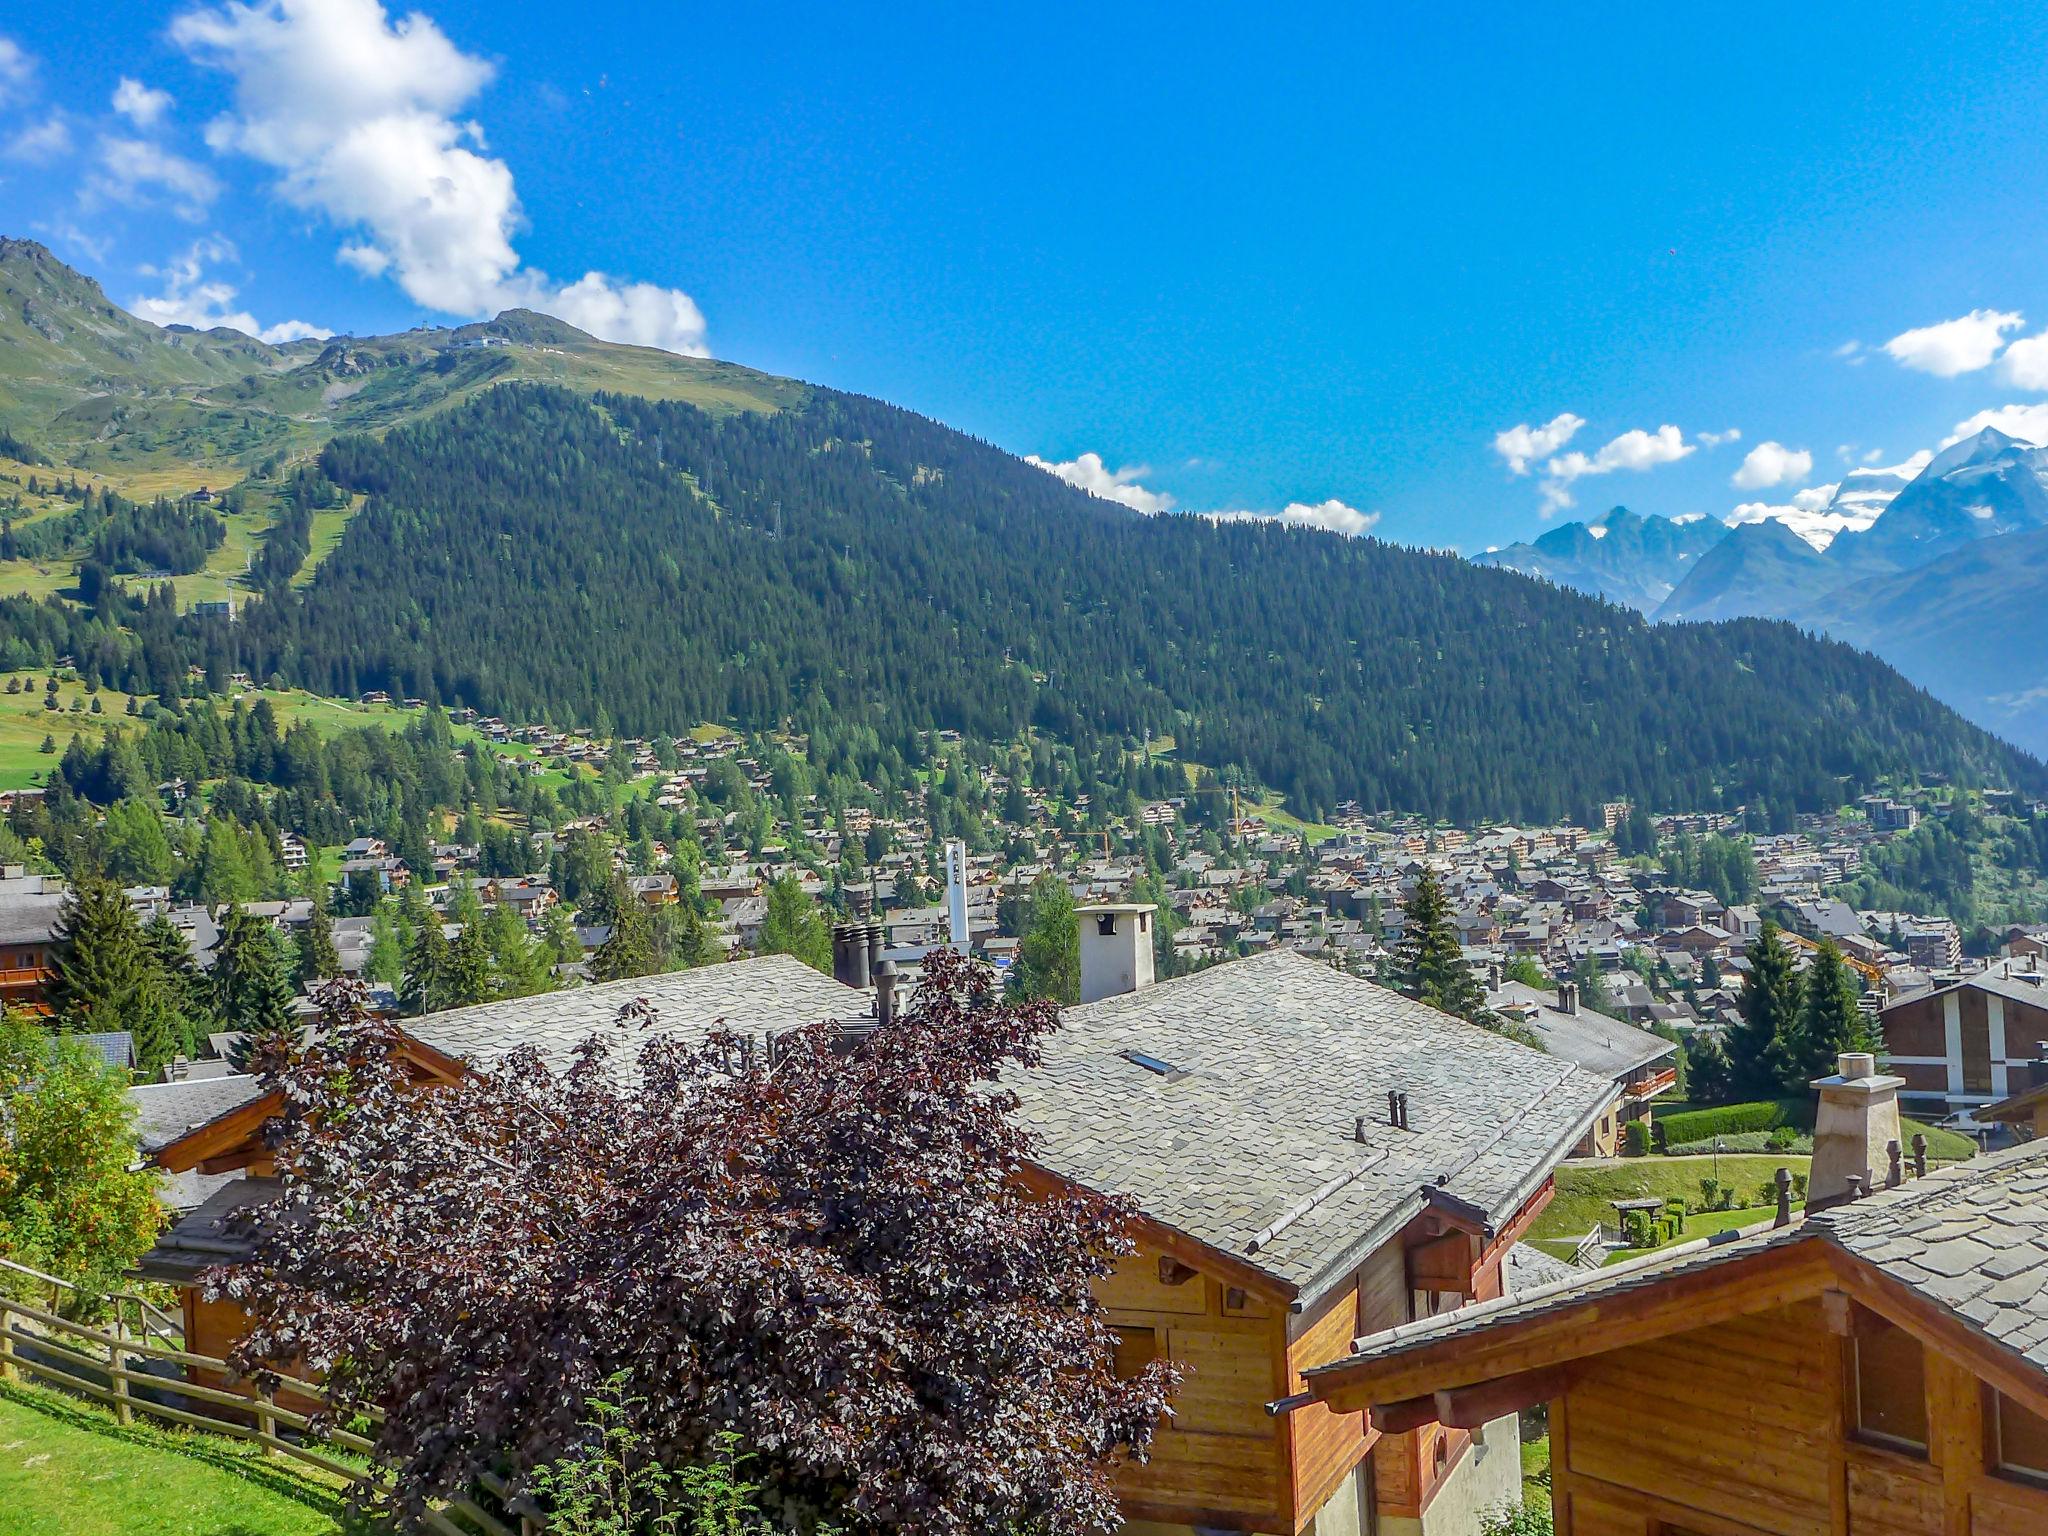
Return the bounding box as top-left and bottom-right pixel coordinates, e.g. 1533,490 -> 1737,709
1550,1298 -> 2048,1536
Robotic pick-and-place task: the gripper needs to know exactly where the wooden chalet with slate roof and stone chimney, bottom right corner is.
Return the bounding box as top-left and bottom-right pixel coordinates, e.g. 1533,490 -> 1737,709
1282,1057 -> 2048,1536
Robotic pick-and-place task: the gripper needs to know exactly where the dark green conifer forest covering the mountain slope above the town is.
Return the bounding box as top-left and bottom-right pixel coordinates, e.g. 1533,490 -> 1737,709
123,385 -> 2048,819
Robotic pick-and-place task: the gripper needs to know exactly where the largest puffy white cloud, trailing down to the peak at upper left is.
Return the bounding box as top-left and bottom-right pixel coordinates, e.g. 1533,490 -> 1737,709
170,0 -> 707,356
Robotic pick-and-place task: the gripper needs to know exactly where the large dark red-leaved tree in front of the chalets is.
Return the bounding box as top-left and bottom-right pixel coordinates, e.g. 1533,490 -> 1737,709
209,954 -> 1174,1536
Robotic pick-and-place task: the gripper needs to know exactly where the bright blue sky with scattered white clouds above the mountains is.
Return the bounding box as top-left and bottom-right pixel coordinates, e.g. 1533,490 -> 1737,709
0,0 -> 2048,553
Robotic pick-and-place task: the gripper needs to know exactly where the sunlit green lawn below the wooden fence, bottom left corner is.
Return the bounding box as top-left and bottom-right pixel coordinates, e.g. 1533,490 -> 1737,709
0,1386 -> 365,1536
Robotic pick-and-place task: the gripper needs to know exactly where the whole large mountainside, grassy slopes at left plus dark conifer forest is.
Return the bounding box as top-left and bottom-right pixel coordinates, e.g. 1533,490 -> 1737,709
0,242 -> 2048,835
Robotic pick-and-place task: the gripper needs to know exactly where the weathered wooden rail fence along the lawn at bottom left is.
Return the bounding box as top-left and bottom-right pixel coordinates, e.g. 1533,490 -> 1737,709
0,1260 -> 524,1536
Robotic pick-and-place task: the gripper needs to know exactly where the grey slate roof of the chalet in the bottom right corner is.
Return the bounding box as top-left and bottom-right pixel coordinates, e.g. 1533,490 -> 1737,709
1309,1143 -> 2048,1376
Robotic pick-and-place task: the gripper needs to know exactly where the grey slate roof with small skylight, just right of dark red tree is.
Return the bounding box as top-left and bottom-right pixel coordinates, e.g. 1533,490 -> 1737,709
1010,952 -> 1614,1300
